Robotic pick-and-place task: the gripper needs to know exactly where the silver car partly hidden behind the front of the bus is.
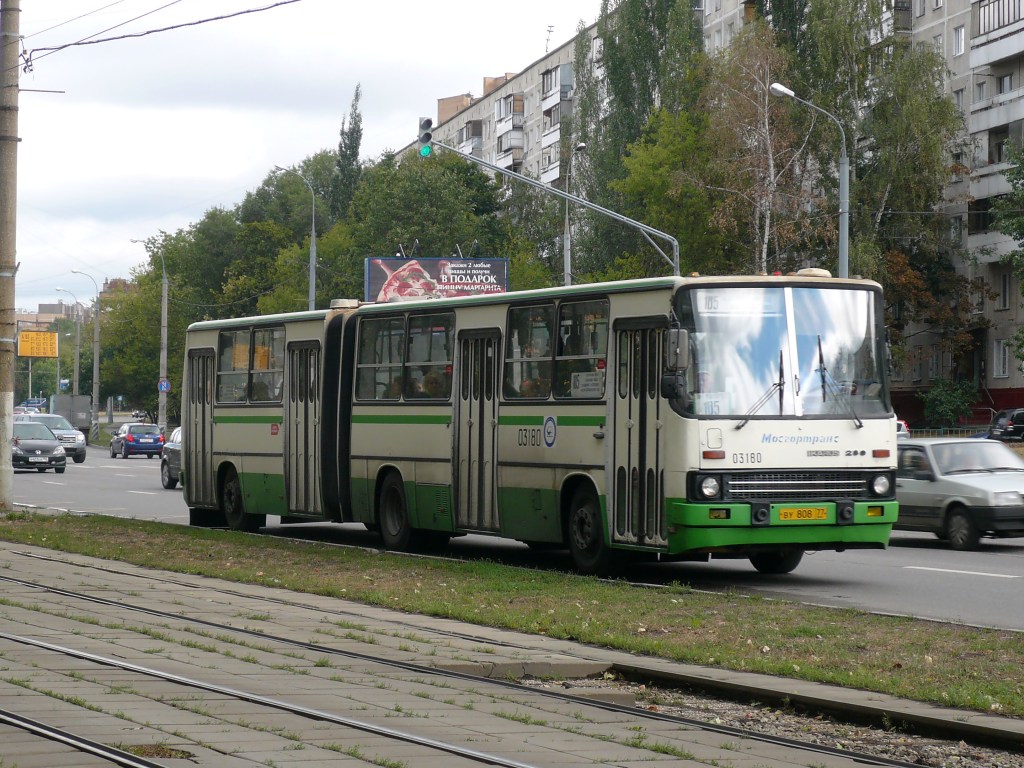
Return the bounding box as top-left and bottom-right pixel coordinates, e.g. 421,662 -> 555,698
895,437 -> 1024,550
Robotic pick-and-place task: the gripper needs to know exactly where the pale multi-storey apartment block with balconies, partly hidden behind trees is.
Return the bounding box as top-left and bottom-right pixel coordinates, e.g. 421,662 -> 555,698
419,0 -> 1024,422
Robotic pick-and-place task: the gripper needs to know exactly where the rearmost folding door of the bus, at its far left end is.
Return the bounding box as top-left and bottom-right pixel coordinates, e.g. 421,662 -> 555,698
181,349 -> 217,508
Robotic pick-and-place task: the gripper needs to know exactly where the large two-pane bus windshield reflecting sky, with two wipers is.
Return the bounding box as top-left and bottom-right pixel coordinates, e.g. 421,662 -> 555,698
676,285 -> 891,421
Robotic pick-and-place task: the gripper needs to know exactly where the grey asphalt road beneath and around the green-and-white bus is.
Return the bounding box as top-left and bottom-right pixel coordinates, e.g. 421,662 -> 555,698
14,445 -> 1024,631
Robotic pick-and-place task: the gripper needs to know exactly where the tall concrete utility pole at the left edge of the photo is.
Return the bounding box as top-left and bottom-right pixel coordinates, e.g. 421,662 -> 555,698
0,0 -> 22,511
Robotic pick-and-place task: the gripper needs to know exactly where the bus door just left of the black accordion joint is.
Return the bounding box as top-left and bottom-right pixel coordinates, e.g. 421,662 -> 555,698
284,341 -> 323,515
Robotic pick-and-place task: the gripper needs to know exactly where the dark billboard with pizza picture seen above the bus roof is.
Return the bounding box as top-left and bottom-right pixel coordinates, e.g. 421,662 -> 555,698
364,257 -> 508,302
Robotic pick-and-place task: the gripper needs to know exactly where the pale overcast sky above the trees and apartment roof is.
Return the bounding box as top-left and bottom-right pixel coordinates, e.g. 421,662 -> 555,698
16,0 -> 600,311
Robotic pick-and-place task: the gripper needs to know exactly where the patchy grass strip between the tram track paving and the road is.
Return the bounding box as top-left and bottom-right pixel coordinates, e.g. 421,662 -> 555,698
0,512 -> 1024,717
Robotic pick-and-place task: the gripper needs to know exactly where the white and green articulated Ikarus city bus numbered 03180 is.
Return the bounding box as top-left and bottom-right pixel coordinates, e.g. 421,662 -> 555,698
182,270 -> 897,573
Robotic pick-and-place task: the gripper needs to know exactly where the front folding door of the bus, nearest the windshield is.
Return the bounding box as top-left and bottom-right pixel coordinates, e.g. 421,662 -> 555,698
611,327 -> 668,546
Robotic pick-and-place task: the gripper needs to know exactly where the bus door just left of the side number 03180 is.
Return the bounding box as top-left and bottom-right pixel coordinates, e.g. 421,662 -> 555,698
452,331 -> 501,530
